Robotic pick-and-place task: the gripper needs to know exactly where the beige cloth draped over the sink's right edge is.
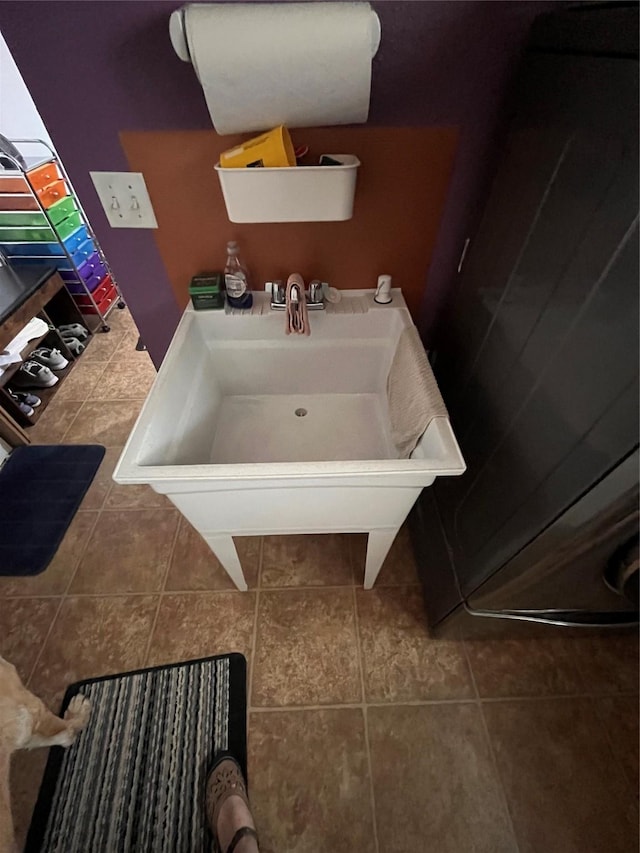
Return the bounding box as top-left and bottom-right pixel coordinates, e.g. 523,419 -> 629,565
387,326 -> 448,459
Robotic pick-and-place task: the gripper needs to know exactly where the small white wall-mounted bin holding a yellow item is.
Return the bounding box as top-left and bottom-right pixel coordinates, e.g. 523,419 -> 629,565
215,154 -> 360,222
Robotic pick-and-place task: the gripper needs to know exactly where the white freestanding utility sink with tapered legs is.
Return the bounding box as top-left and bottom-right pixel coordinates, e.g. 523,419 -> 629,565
114,290 -> 465,589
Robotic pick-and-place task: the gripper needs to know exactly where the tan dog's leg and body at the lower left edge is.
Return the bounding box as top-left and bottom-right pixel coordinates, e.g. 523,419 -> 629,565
0,657 -> 91,853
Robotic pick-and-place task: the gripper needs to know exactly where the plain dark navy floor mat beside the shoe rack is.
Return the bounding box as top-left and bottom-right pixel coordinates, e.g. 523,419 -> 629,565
0,445 -> 105,576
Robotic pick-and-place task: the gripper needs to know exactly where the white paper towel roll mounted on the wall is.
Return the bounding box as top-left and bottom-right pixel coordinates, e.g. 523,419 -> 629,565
170,3 -> 380,134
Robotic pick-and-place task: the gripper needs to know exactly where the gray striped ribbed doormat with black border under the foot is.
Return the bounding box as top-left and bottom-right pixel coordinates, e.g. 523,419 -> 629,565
25,654 -> 246,853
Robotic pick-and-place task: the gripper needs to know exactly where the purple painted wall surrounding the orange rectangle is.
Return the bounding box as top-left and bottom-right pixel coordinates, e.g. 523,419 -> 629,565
0,0 -> 553,363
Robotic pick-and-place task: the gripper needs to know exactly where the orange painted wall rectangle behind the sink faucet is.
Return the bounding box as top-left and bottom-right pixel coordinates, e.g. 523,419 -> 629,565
120,126 -> 458,319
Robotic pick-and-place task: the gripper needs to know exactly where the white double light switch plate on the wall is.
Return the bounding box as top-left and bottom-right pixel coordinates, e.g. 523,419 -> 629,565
89,172 -> 158,228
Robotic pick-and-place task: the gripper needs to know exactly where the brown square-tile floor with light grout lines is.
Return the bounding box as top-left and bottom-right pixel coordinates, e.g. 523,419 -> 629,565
0,312 -> 638,853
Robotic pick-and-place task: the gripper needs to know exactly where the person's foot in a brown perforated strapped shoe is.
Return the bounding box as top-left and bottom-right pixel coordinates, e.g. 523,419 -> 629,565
206,756 -> 258,853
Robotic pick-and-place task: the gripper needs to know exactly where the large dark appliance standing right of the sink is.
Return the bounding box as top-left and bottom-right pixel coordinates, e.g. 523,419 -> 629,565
410,4 -> 638,636
